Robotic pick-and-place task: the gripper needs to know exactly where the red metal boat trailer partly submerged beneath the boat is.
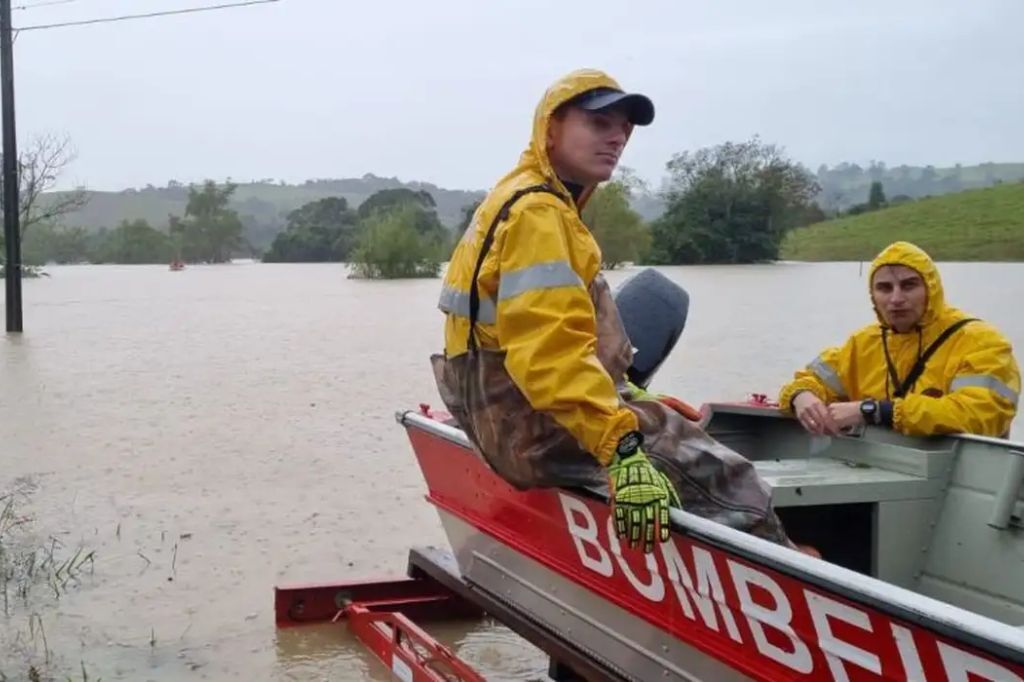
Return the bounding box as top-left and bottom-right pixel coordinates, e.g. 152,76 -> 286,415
274,547 -> 627,682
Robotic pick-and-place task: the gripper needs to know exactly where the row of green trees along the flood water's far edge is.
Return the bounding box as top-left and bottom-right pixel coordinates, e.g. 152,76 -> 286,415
4,137 -> 905,278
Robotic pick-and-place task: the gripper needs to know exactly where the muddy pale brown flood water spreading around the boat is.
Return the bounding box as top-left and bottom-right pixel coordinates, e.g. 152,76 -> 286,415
0,263 -> 1024,681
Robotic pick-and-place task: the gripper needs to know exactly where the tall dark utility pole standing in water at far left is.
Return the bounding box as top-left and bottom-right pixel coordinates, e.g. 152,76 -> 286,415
0,0 -> 22,333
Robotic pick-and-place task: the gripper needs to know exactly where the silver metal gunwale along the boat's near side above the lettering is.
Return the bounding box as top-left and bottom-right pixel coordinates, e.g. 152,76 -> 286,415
395,411 -> 1024,665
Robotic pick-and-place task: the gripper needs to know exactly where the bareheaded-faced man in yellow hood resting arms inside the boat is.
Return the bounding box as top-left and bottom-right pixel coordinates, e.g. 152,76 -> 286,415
779,242 -> 1021,436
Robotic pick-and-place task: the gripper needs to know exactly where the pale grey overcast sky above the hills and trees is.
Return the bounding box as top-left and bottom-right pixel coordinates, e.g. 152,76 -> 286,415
14,0 -> 1024,189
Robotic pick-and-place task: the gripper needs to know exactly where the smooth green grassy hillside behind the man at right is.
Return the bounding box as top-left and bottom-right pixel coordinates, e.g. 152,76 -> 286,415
781,182 -> 1024,261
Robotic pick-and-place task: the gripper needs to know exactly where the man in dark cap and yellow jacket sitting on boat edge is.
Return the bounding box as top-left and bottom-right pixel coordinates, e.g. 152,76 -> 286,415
431,70 -> 806,552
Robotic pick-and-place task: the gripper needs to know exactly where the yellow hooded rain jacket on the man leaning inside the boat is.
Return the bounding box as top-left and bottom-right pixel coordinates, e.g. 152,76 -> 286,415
779,242 -> 1021,436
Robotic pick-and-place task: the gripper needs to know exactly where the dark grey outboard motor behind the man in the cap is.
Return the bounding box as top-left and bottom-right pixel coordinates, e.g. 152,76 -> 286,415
614,268 -> 690,388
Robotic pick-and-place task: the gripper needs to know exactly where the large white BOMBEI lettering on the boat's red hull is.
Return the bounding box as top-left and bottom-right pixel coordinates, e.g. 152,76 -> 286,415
558,493 -> 1024,682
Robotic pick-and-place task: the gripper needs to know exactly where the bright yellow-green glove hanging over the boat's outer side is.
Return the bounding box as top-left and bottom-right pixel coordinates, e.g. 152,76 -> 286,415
608,432 -> 682,553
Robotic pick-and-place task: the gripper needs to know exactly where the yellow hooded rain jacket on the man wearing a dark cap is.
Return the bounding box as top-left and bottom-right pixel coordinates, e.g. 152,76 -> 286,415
439,70 -> 638,465
